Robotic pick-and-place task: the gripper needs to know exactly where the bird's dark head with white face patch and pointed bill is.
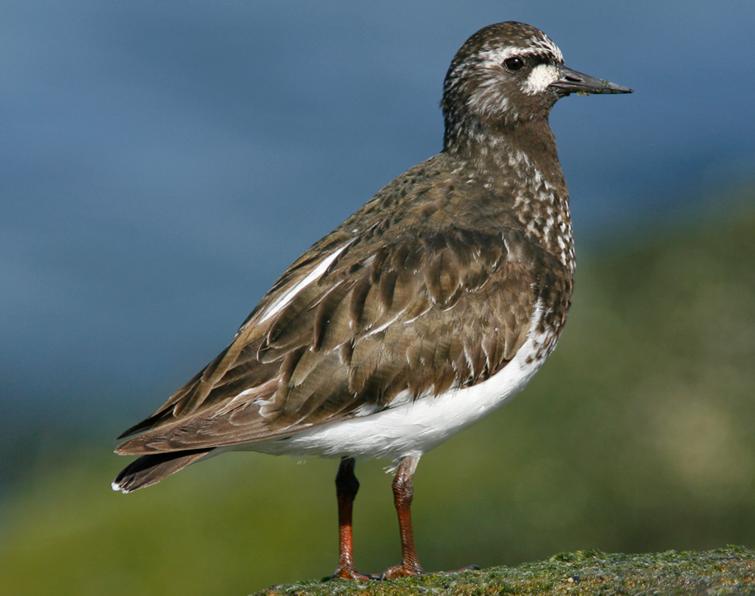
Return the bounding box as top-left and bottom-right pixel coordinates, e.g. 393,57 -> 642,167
441,21 -> 632,146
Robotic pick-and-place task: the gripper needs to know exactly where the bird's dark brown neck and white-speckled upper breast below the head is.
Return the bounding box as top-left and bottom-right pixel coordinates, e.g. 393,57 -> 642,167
443,118 -> 575,271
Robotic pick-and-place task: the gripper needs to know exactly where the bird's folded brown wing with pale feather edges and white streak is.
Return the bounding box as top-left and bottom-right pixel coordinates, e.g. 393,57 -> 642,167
118,226 -> 541,454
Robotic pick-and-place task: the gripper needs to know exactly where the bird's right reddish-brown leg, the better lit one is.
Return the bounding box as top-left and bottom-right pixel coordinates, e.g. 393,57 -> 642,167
382,455 -> 422,579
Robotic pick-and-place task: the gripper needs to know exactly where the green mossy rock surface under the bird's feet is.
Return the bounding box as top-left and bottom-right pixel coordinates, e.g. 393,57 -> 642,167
260,546 -> 755,595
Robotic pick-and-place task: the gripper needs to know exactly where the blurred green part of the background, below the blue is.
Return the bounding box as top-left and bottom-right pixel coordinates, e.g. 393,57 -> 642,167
0,195 -> 755,595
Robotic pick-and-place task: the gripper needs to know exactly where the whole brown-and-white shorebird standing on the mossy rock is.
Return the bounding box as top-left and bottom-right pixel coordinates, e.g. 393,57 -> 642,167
113,22 -> 631,579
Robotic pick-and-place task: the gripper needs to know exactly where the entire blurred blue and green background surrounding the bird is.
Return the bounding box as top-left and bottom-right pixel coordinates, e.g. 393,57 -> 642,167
0,0 -> 755,594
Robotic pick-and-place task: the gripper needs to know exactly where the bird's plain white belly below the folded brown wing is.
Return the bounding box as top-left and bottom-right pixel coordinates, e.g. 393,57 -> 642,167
251,303 -> 545,458
